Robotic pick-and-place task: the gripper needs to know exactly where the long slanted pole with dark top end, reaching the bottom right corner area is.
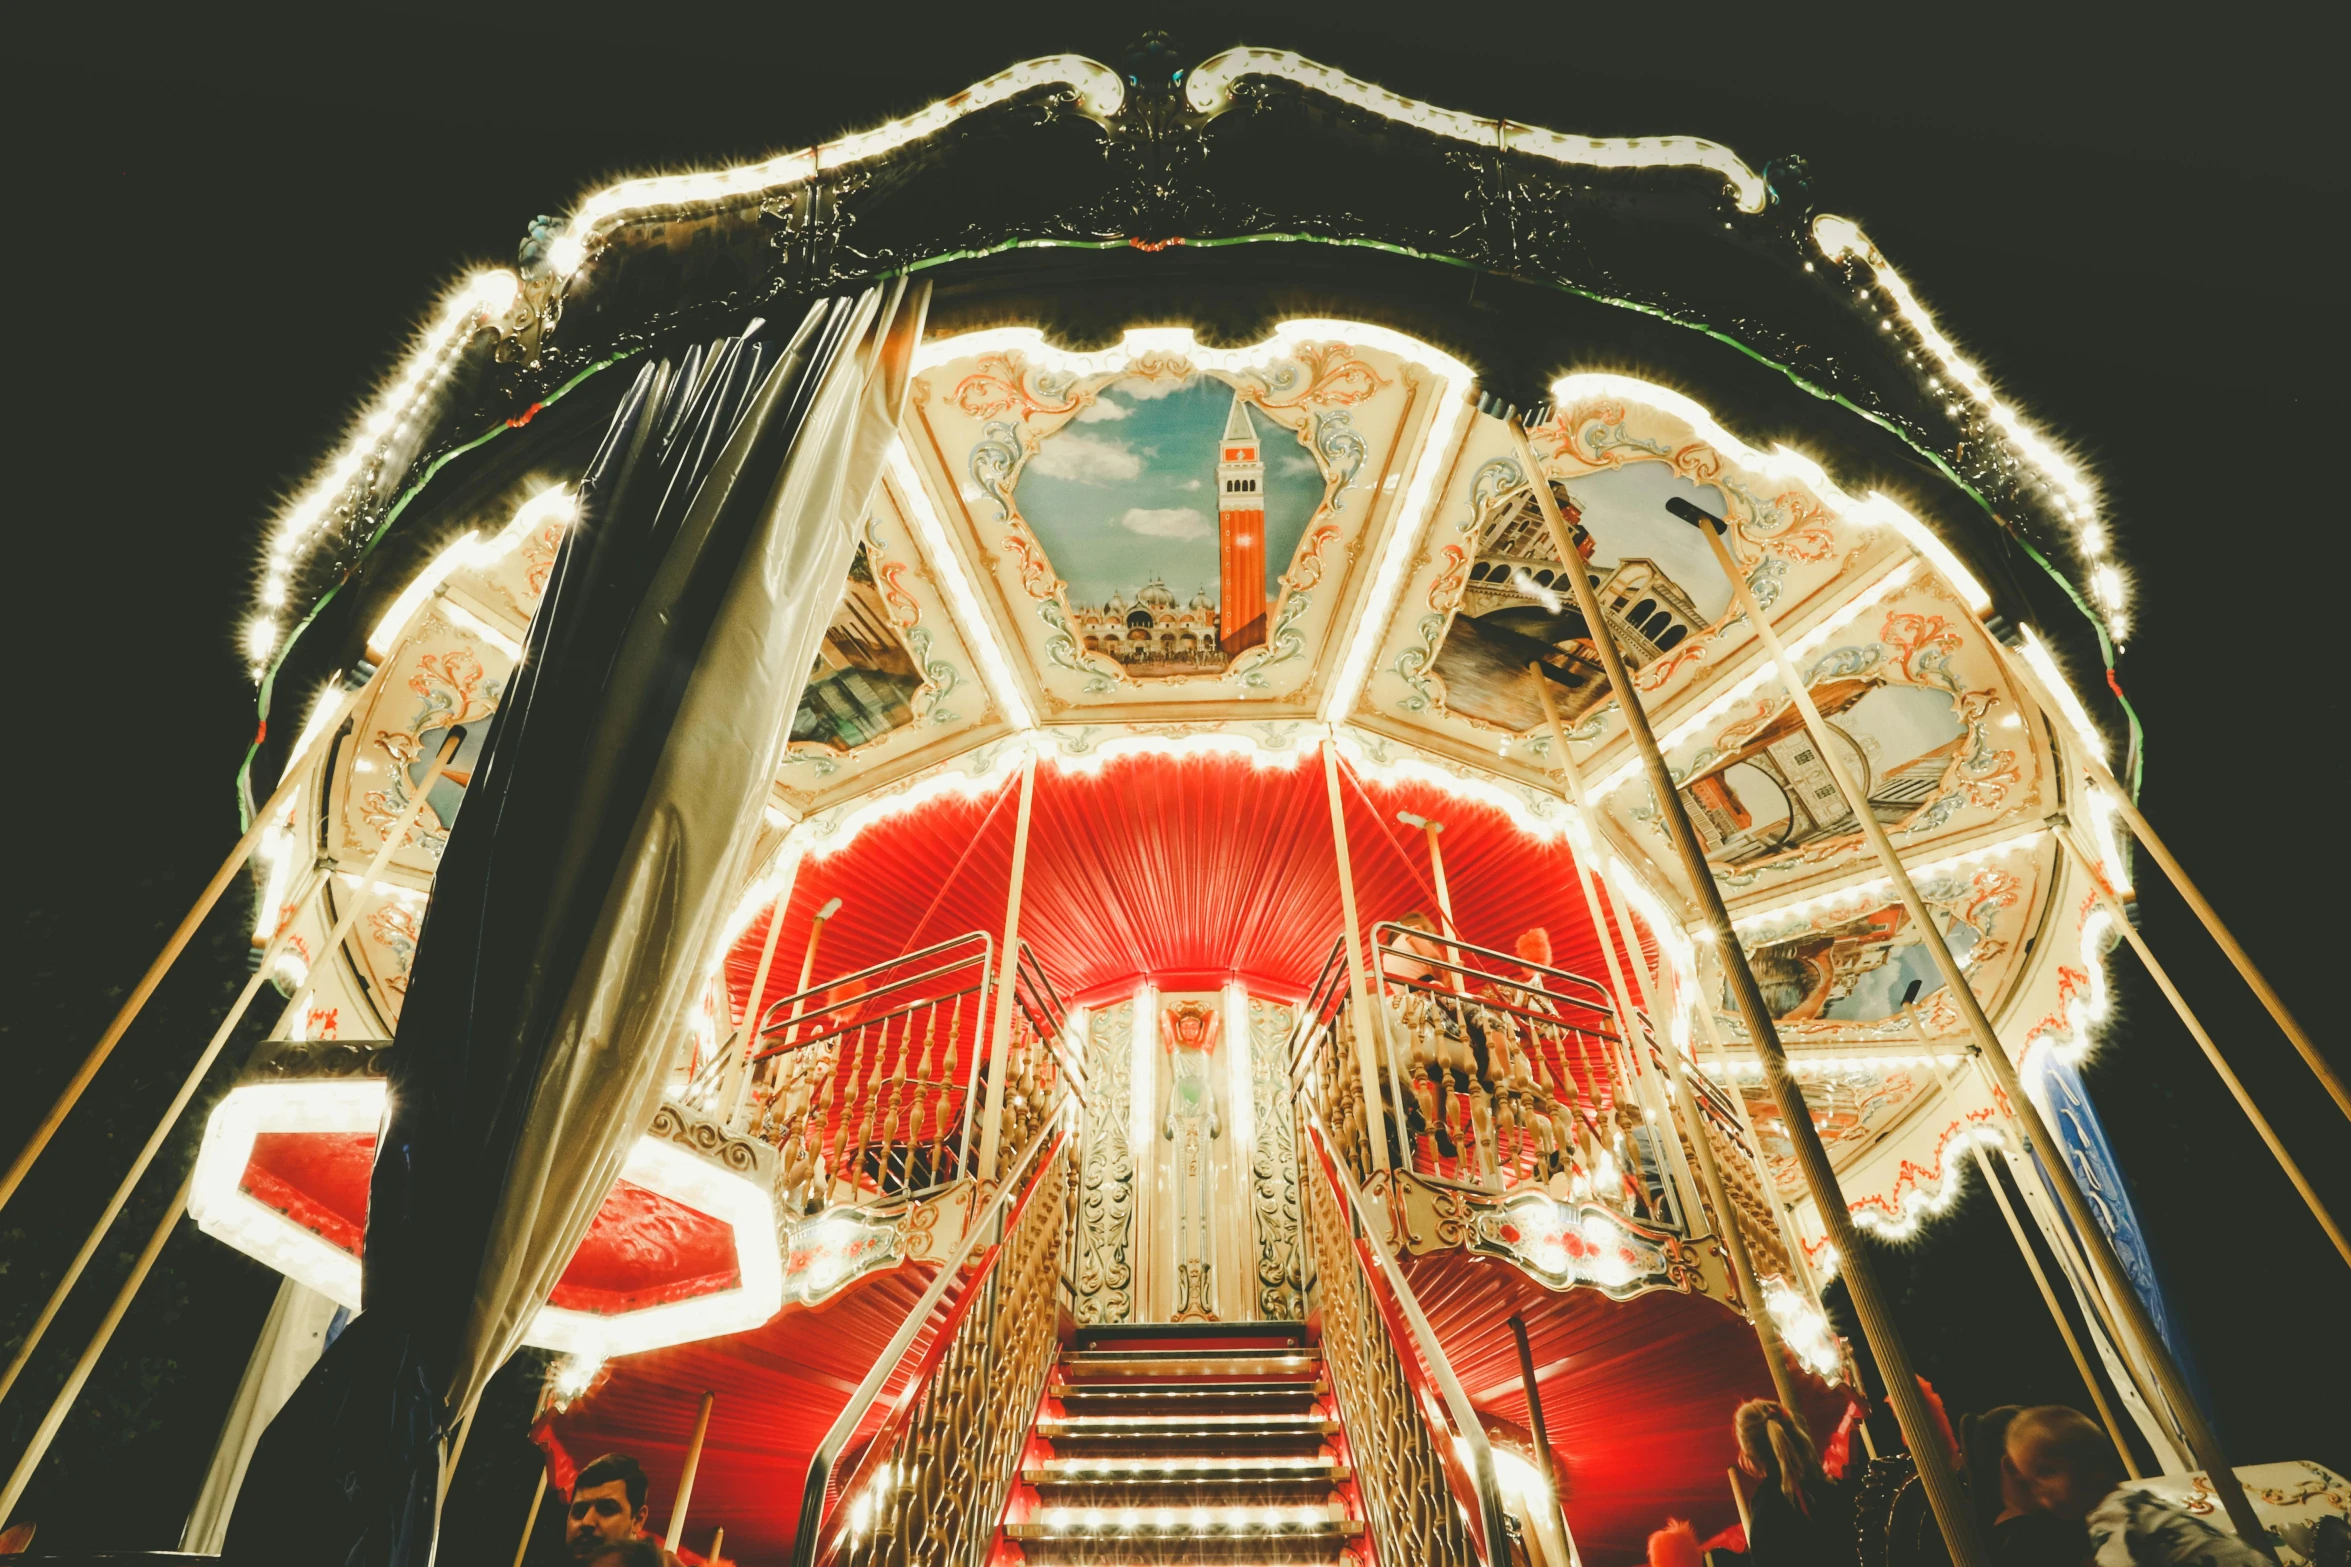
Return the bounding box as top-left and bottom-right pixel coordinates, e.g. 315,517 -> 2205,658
1673,498 -> 2269,1555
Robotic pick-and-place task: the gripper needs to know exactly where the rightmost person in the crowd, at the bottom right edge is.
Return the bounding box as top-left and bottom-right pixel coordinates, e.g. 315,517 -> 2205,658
2005,1405 -> 2269,1567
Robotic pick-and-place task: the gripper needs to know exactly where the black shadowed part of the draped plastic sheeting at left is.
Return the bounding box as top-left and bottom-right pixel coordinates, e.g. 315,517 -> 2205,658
228,298 -> 853,1567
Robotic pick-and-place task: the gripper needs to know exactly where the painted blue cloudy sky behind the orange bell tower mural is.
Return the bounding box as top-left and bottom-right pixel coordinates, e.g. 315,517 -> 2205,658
1013,376 -> 1324,604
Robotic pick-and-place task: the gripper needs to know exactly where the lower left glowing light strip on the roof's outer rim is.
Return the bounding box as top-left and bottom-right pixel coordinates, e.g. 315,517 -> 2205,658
245,270 -> 522,679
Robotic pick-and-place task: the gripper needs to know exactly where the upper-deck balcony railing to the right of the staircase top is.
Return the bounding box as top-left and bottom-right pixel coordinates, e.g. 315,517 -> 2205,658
1291,923 -> 1688,1233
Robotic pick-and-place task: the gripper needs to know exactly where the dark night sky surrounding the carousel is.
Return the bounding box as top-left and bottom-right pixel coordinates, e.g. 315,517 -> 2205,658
0,2 -> 2351,1562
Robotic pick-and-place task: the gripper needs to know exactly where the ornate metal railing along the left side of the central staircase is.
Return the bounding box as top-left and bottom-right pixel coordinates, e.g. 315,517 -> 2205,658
792,1108 -> 1072,1567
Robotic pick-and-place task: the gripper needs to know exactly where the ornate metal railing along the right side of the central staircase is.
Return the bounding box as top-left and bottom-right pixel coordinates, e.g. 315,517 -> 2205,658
1298,1109 -> 1512,1567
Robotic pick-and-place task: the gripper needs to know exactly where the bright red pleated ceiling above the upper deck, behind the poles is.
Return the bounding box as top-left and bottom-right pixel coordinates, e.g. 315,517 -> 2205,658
726,752 -> 1645,1006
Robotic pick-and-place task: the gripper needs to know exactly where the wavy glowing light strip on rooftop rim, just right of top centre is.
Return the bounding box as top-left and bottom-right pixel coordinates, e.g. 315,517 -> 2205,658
1185,47 -> 1768,211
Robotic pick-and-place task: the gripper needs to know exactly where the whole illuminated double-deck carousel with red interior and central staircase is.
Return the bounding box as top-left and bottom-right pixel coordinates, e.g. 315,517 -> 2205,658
0,40 -> 2351,1567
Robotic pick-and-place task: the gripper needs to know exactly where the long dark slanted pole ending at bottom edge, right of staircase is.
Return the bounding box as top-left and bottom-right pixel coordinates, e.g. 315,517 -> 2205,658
1509,413 -> 1991,1567
